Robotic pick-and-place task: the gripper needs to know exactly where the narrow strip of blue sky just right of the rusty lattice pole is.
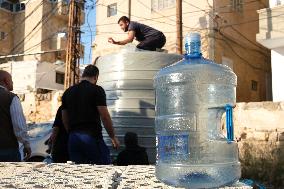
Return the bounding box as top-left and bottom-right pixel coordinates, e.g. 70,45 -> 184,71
81,6 -> 96,64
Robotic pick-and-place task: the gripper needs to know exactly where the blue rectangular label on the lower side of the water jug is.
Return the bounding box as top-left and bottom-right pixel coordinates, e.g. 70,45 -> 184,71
158,134 -> 189,160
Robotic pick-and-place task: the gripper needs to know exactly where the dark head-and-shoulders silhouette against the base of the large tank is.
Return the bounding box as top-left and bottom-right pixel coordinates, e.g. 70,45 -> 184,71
116,132 -> 149,166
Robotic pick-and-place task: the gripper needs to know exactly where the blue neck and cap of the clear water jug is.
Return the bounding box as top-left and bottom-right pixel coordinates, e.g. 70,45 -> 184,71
185,35 -> 202,59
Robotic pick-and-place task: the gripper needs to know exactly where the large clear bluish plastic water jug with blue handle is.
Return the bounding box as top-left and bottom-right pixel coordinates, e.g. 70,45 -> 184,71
154,33 -> 241,189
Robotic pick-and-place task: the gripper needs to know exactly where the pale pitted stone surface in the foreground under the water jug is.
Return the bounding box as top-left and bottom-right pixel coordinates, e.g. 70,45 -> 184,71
0,163 -> 251,189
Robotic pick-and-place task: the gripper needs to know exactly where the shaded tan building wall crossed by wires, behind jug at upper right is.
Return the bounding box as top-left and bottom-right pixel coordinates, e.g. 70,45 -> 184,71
214,0 -> 271,102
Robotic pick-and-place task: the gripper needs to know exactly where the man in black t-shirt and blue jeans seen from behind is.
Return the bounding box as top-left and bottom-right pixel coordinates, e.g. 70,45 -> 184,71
62,65 -> 119,165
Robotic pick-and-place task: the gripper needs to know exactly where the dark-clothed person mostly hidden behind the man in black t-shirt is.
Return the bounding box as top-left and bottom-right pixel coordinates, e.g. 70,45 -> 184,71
49,106 -> 69,163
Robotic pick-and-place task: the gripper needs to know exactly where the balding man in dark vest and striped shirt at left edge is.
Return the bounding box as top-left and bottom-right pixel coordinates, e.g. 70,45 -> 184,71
0,70 -> 31,162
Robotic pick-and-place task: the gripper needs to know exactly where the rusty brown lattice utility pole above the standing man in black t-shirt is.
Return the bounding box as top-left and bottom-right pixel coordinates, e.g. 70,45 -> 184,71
64,0 -> 84,89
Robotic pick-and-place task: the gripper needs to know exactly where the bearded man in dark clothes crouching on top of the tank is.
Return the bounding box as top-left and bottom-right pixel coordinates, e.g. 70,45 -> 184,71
108,16 -> 166,51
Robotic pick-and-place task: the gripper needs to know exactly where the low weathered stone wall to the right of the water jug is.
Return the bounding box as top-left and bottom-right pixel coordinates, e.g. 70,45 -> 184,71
234,102 -> 284,189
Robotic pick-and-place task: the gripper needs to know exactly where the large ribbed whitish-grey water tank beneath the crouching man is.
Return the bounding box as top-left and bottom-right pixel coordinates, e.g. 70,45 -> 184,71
96,46 -> 182,164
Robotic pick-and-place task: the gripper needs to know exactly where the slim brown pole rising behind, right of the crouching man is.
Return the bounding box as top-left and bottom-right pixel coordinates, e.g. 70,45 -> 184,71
176,0 -> 183,54
